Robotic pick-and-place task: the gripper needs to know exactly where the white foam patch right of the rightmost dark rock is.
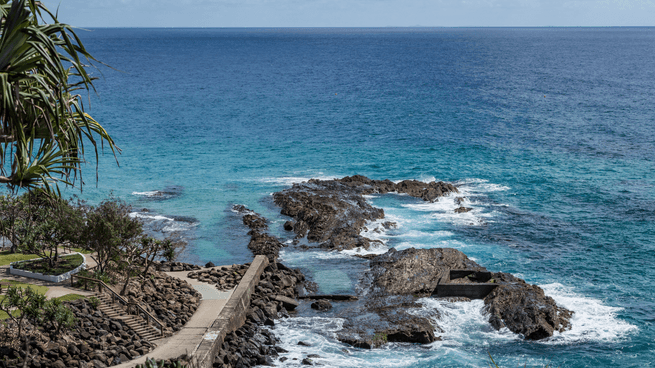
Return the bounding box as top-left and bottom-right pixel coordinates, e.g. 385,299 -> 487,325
541,283 -> 638,344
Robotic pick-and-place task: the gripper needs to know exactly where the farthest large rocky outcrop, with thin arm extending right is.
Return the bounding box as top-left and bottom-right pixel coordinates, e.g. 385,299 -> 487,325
273,175 -> 457,250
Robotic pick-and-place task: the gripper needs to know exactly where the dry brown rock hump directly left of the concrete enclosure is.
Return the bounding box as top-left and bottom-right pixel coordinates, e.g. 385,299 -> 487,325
371,248 -> 484,295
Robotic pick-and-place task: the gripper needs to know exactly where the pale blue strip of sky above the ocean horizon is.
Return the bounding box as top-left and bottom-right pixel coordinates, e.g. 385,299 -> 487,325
42,0 -> 655,28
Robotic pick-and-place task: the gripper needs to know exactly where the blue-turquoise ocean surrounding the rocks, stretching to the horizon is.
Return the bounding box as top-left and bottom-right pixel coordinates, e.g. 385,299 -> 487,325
70,28 -> 655,367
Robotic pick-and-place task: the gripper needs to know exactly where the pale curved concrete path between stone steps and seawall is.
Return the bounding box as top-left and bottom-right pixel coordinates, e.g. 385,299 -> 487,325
112,266 -> 233,368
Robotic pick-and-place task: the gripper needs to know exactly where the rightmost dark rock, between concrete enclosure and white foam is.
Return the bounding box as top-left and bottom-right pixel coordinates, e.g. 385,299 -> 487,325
484,273 -> 573,340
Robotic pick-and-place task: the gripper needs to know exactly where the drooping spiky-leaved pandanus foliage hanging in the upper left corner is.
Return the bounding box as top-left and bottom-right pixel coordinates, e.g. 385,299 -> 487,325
0,0 -> 120,191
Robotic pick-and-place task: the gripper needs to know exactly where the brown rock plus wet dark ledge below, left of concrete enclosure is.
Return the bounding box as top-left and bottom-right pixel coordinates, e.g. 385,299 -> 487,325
337,248 -> 476,349
